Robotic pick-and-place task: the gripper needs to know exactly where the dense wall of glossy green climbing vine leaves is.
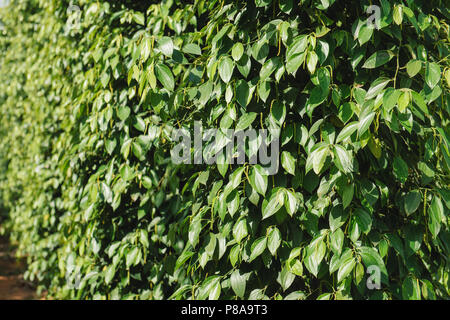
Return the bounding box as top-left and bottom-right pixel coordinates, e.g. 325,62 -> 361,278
0,0 -> 450,299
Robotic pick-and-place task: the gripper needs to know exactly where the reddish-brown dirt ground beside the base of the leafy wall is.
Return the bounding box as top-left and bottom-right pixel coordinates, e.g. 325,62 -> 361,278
0,237 -> 37,300
